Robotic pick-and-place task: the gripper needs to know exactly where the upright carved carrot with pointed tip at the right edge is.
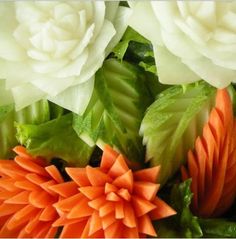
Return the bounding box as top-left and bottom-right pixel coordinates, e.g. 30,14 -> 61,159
181,89 -> 236,217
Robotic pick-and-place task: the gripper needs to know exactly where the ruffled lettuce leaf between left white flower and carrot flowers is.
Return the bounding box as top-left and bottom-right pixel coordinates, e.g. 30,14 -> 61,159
16,113 -> 93,167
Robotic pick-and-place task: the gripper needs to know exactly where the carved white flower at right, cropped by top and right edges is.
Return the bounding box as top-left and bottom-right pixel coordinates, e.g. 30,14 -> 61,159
130,1 -> 236,88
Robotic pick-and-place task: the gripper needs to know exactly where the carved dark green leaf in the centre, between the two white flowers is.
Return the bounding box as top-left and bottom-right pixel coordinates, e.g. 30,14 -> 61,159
73,59 -> 150,161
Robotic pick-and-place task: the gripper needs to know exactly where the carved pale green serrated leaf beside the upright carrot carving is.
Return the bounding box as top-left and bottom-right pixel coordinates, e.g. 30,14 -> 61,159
140,82 -> 215,184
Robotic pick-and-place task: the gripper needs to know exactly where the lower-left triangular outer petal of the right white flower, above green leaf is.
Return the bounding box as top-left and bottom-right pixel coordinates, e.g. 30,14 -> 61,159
154,45 -> 200,85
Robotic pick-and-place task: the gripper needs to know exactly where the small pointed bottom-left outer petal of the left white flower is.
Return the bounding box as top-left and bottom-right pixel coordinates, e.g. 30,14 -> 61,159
12,83 -> 46,111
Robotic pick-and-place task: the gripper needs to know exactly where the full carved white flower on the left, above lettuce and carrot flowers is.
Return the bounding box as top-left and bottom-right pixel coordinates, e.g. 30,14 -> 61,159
0,0 -> 131,113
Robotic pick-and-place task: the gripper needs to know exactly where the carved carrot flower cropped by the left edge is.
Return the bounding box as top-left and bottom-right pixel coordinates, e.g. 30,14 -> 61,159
0,146 -> 68,238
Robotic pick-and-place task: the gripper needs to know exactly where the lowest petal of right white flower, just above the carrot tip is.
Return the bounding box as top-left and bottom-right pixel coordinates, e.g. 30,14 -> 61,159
182,57 -> 236,88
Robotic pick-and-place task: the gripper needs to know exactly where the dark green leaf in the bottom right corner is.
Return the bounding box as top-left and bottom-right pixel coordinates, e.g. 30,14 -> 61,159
199,218 -> 236,238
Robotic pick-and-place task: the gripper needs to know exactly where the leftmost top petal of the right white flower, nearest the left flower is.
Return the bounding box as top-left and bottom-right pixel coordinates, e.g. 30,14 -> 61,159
128,1 -> 162,45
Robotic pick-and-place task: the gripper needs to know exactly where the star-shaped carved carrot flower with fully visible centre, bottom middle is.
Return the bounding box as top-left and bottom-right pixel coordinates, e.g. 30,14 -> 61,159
54,146 -> 175,238
